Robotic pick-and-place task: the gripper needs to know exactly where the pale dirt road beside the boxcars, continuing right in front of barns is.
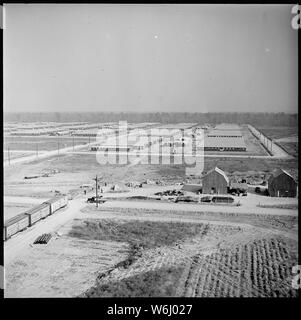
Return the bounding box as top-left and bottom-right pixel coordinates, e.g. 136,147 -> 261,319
4,197 -> 298,263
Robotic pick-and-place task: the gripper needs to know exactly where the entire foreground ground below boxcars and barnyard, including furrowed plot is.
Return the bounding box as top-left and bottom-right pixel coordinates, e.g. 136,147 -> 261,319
5,197 -> 298,297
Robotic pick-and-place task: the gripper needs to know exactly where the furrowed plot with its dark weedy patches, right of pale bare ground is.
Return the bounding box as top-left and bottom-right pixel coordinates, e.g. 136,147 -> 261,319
69,217 -> 298,297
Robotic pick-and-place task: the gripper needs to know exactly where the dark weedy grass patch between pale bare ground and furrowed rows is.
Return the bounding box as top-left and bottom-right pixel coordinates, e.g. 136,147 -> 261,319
69,219 -> 208,297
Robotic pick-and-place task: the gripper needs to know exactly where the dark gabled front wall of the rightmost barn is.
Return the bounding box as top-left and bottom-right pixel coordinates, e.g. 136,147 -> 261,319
268,173 -> 297,197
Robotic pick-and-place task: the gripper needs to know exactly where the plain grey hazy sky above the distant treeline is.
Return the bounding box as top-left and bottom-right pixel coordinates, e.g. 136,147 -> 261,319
3,4 -> 298,112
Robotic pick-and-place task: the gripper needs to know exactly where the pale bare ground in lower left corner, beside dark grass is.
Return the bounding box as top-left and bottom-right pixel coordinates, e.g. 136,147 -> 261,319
5,235 -> 127,298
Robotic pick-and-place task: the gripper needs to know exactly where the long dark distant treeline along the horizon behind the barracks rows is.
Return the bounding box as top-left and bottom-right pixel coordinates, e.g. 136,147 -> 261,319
4,112 -> 298,126
